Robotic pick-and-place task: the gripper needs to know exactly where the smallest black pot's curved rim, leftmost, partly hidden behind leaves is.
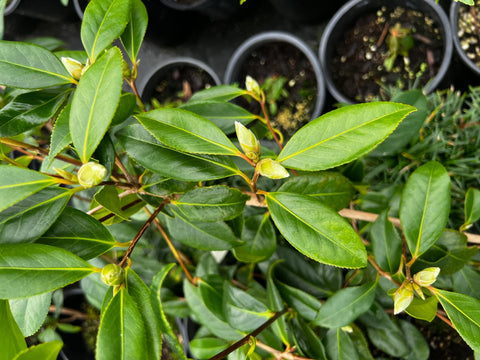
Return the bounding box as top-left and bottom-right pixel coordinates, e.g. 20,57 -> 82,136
139,57 -> 221,102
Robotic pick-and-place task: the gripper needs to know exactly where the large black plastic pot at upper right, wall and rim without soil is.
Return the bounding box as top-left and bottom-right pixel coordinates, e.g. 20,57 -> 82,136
319,0 -> 453,104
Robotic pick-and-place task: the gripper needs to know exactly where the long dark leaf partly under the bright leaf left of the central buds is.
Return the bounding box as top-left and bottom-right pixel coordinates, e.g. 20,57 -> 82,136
117,125 -> 239,181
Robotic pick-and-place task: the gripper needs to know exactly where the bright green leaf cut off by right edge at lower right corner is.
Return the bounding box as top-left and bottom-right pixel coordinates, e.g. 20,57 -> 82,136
434,289 -> 480,352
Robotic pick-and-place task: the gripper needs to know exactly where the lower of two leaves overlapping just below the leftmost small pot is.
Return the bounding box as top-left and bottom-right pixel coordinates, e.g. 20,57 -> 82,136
180,100 -> 256,135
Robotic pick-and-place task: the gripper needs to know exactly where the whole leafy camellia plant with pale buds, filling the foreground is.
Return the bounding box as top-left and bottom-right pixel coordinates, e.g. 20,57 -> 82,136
0,0 -> 480,360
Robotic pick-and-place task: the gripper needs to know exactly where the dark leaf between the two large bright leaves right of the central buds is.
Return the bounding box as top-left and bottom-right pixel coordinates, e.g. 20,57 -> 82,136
278,171 -> 355,210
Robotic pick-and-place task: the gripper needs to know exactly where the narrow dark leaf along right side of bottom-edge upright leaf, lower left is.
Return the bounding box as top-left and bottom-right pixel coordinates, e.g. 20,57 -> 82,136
126,269 -> 162,360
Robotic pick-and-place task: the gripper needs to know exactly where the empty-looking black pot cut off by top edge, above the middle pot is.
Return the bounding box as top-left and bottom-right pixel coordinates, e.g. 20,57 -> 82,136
270,0 -> 345,23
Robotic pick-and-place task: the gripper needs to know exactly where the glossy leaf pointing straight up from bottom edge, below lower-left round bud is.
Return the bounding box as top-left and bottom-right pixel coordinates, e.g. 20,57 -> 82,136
95,288 -> 147,360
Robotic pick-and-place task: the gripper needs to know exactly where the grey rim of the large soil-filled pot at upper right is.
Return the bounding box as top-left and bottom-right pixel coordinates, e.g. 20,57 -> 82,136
318,0 -> 453,104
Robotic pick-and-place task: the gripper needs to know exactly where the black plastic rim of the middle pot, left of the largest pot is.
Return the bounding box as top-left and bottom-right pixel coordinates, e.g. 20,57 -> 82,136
224,31 -> 326,119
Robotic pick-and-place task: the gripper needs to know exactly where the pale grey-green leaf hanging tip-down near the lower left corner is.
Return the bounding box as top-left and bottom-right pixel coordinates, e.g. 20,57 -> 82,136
10,292 -> 52,337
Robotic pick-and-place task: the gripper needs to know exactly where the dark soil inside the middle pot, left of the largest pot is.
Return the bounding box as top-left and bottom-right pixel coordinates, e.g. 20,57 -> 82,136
239,42 -> 317,136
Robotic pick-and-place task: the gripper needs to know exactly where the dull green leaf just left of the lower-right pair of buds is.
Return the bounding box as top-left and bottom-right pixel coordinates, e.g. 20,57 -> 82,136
314,281 -> 377,329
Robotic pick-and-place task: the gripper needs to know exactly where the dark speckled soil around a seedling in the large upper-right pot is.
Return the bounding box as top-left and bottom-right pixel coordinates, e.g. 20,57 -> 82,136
332,7 -> 443,102
